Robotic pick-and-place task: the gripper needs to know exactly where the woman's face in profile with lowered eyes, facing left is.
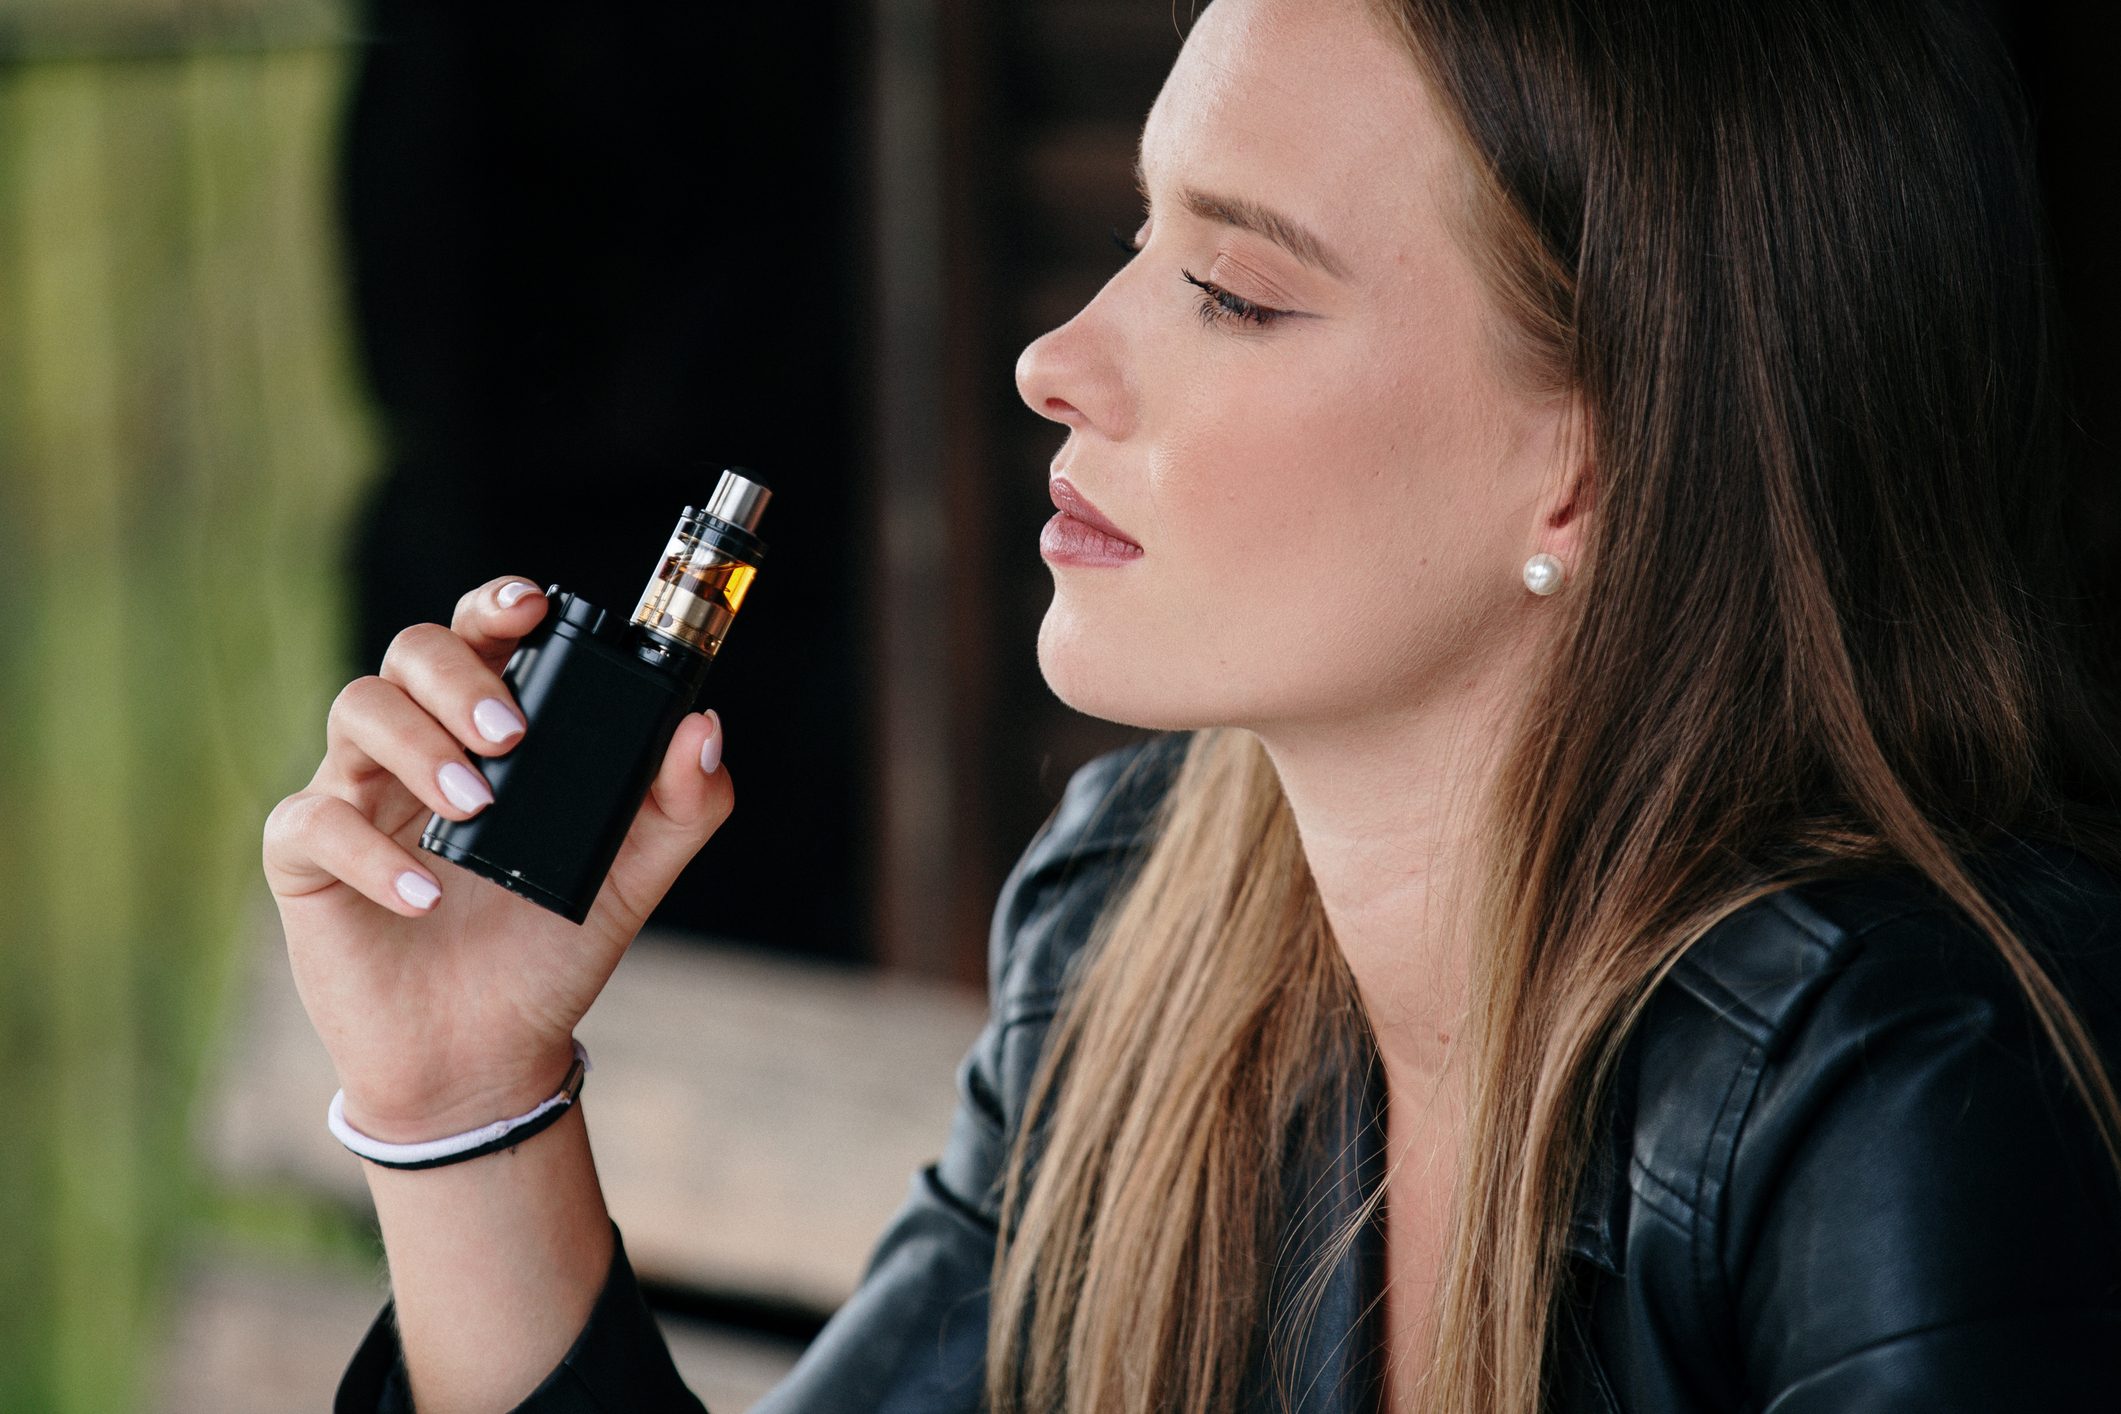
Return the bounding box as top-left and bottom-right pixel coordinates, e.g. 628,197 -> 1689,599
1016,0 -> 1580,731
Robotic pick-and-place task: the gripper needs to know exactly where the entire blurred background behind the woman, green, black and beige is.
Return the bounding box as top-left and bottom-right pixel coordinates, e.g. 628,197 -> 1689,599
0,0 -> 2121,1414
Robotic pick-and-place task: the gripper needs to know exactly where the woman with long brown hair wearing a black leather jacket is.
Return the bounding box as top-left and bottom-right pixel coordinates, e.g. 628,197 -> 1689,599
265,0 -> 2121,1414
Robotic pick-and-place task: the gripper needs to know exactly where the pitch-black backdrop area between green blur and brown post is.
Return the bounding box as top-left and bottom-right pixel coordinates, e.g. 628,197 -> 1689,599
341,0 -> 874,958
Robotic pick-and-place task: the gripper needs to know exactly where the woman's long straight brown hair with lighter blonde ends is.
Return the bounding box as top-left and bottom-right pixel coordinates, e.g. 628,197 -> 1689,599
988,0 -> 2121,1414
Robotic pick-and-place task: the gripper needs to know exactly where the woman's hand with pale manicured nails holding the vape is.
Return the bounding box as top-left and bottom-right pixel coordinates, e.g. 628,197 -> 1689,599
265,577 -> 734,1143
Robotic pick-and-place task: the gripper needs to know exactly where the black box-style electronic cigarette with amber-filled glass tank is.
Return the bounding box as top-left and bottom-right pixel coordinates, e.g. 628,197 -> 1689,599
420,466 -> 772,922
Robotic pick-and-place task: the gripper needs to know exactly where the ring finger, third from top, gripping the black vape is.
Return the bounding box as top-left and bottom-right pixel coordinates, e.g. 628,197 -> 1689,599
314,674 -> 494,820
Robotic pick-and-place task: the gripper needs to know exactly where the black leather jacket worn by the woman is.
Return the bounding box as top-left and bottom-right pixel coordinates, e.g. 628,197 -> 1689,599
337,733 -> 2121,1414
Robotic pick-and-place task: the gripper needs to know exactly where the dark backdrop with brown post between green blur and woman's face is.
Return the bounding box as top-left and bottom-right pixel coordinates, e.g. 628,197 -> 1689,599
341,0 -> 1179,982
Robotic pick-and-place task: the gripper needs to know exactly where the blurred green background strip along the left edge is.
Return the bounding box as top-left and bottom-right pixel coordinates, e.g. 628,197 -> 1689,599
0,0 -> 373,1414
